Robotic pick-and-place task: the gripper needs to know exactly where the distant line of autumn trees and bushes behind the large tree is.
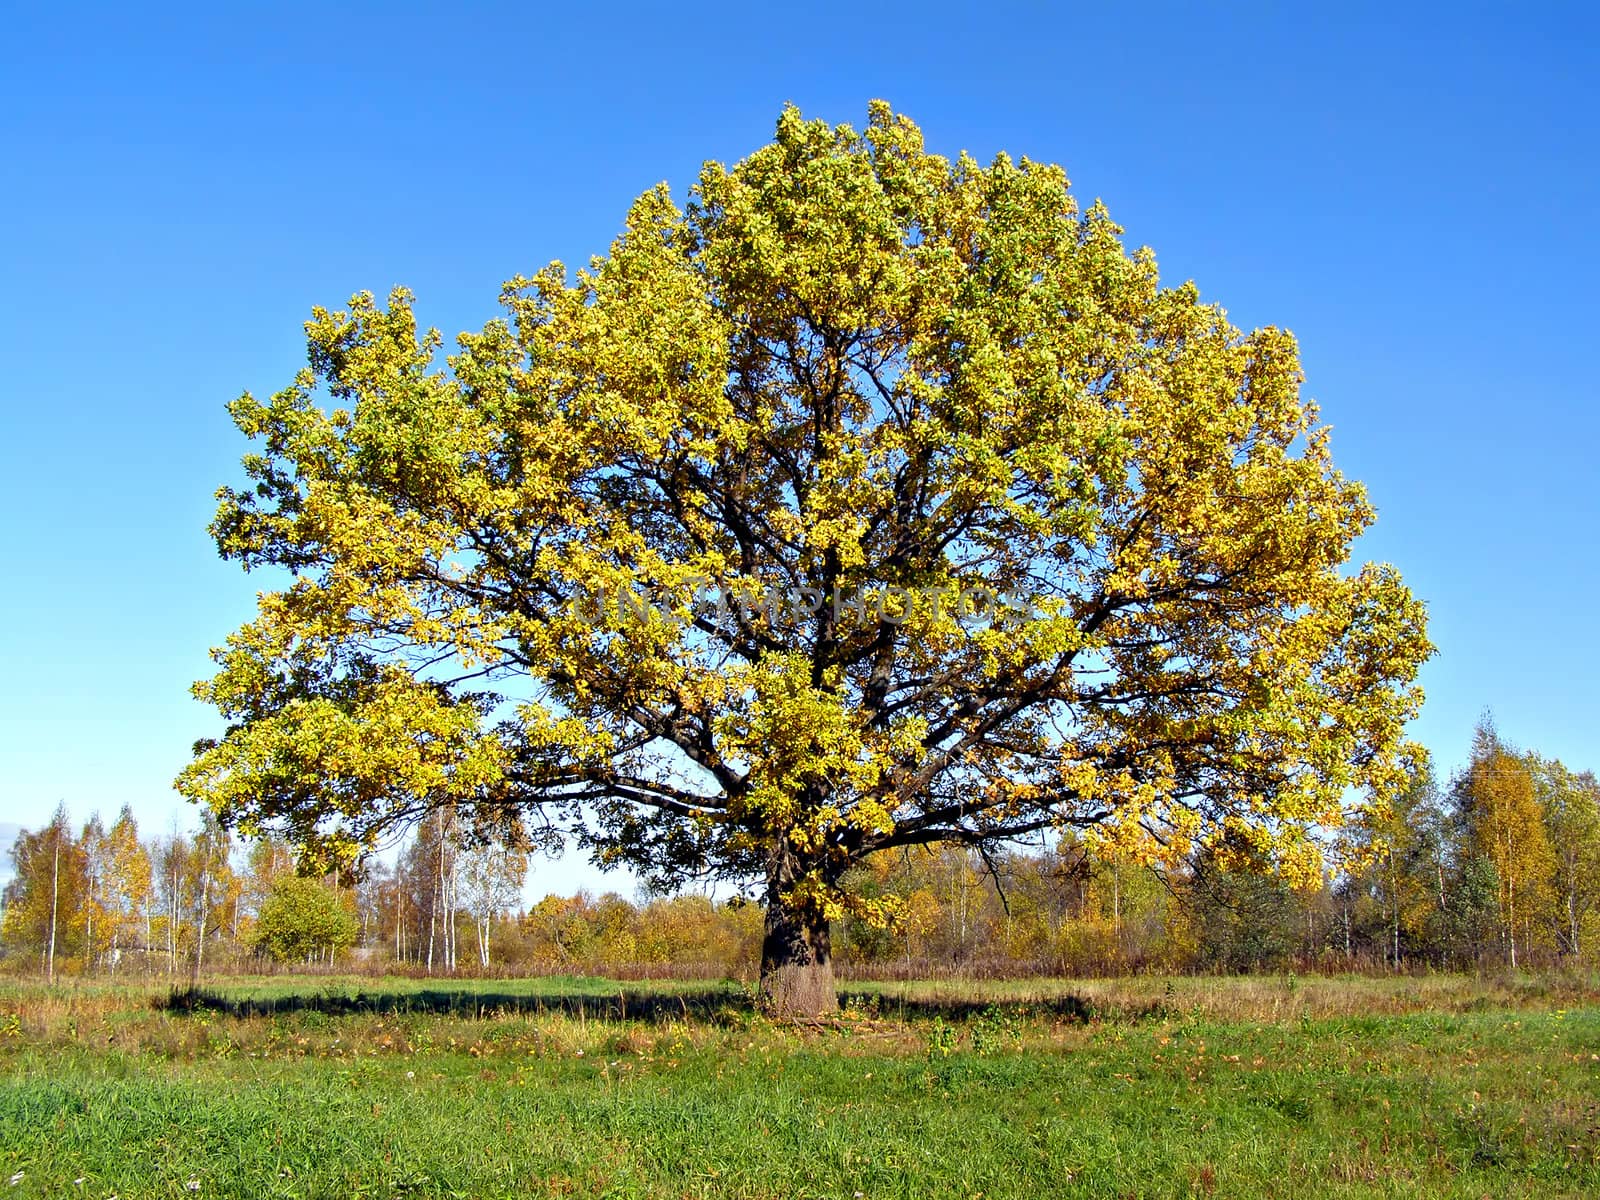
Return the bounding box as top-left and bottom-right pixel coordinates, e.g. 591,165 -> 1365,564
0,720 -> 1600,978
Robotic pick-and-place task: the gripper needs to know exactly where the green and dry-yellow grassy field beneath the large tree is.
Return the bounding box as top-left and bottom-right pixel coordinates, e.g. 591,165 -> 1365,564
0,976 -> 1600,1200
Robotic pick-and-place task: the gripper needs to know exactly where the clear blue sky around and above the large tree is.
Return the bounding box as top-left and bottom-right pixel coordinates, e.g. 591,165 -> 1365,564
0,3 -> 1600,890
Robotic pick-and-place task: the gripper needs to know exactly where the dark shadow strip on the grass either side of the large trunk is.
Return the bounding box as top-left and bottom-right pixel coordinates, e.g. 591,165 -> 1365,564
155,986 -> 1139,1024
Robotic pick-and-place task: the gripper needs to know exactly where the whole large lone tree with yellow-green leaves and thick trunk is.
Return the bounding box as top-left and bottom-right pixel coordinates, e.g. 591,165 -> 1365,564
179,104 -> 1430,1010
